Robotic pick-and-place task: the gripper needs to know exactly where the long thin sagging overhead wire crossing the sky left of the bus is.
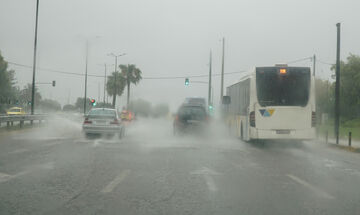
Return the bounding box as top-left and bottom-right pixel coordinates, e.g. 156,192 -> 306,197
8,61 -> 244,80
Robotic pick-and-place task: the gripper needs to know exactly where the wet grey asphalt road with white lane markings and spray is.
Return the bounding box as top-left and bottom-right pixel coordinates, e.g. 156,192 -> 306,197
0,118 -> 360,215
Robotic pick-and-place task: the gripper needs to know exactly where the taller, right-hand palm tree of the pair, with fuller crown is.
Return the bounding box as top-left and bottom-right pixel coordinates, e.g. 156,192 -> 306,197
119,64 -> 142,107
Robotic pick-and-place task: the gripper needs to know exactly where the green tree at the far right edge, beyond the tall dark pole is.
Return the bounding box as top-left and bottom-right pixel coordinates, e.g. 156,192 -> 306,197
331,54 -> 360,119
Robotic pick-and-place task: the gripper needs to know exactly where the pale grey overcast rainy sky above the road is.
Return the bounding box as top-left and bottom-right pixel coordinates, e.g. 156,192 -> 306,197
0,0 -> 360,109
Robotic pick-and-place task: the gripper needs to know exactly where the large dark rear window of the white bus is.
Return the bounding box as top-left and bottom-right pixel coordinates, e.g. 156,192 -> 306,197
256,67 -> 310,106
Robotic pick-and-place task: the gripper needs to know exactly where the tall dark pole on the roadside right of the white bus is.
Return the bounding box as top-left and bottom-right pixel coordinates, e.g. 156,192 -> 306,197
335,23 -> 340,144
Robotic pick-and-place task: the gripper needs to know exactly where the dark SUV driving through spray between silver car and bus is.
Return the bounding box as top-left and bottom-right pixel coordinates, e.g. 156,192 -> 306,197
174,104 -> 208,135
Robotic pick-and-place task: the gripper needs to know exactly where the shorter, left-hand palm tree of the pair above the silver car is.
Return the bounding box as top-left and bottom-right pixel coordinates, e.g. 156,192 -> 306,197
106,72 -> 125,108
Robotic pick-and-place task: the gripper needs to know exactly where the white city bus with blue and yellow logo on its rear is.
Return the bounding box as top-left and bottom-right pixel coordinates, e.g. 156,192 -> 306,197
223,65 -> 316,140
